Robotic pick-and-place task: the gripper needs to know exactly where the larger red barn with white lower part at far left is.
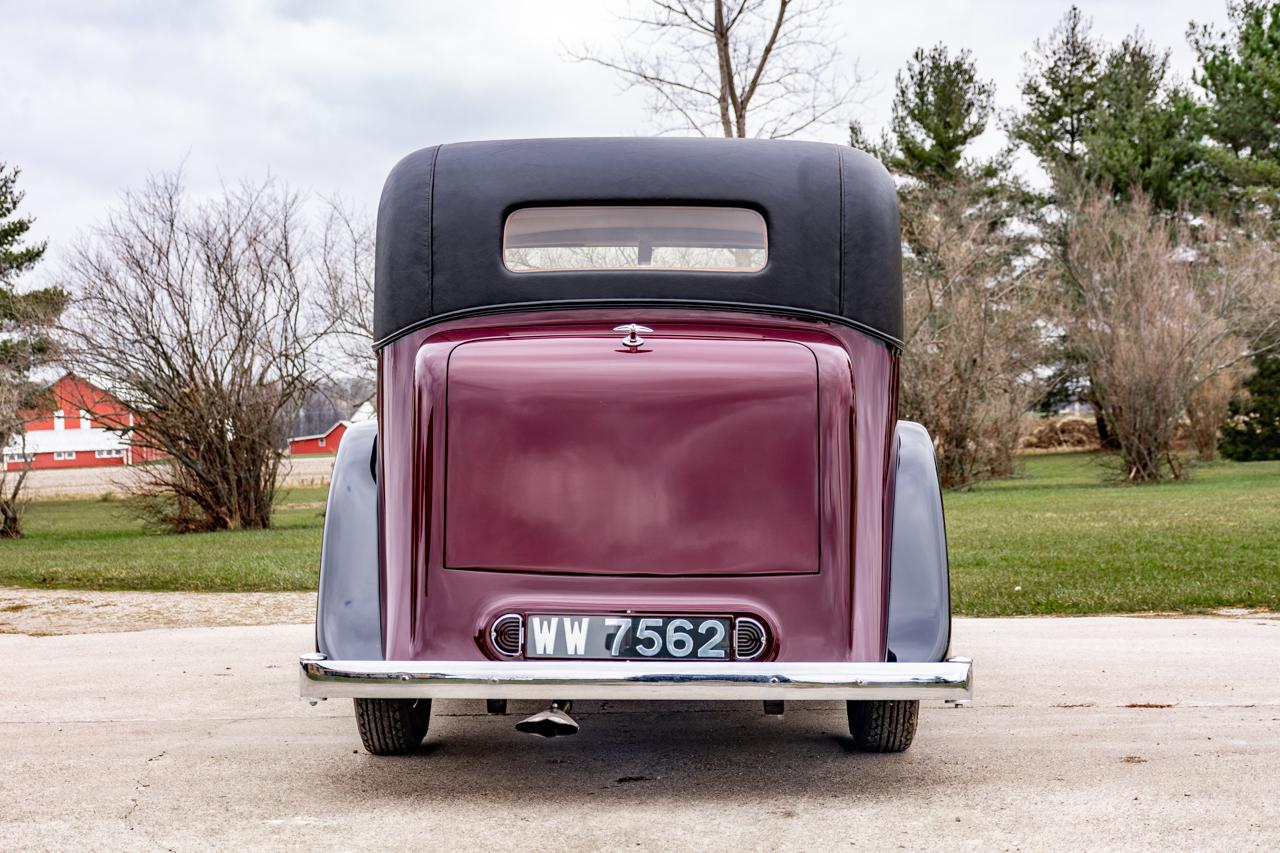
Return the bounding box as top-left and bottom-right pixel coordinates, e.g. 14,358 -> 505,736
3,373 -> 151,470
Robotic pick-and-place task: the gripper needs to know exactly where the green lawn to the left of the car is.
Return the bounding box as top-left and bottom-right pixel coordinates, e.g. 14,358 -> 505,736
0,488 -> 328,592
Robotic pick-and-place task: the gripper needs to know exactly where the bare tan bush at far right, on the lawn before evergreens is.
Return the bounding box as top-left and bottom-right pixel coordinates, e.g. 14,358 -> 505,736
1059,190 -> 1280,483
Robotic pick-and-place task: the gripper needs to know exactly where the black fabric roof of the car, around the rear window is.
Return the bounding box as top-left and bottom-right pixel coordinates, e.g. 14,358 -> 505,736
374,138 -> 902,346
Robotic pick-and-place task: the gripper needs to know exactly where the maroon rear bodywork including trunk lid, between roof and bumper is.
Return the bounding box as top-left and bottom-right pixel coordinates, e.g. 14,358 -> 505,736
378,309 -> 896,661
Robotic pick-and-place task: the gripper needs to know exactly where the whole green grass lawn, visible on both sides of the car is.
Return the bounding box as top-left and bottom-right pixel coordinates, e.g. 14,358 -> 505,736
0,453 -> 1280,616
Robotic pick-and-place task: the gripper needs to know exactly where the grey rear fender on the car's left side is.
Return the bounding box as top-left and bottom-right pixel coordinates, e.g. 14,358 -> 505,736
316,421 -> 383,661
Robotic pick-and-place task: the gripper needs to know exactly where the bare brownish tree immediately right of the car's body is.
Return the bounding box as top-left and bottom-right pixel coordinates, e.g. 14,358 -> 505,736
900,181 -> 1043,488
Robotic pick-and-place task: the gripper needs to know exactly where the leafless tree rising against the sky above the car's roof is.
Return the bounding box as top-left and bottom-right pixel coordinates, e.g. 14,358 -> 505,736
572,0 -> 859,140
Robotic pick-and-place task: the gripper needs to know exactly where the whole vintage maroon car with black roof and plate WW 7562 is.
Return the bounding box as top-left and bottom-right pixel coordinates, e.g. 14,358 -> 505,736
301,138 -> 972,754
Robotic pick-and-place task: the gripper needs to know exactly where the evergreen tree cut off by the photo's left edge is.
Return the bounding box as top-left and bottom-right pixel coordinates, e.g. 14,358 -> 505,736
0,163 -> 65,538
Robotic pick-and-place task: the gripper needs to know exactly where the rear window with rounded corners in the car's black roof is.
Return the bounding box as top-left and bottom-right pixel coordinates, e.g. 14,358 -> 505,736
502,205 -> 768,273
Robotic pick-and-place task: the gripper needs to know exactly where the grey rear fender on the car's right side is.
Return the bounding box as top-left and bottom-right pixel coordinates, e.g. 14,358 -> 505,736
887,420 -> 951,662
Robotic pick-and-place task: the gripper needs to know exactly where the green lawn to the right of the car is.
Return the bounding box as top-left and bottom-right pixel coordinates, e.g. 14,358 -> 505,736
943,453 -> 1280,616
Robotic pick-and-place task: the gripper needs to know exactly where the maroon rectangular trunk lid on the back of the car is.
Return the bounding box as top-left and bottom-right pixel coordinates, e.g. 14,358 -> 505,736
444,334 -> 819,576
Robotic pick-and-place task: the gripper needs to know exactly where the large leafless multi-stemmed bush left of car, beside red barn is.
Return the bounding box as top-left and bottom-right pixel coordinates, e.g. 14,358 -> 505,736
63,174 -> 326,530
